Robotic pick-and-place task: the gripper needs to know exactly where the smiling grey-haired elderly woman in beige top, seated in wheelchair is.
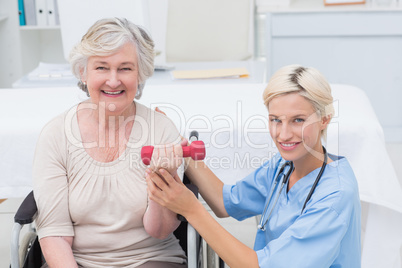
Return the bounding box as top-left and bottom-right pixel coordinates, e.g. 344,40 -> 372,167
33,18 -> 186,268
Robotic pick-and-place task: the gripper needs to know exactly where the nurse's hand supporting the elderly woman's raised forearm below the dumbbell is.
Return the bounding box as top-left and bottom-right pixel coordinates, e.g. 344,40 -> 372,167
146,169 -> 200,217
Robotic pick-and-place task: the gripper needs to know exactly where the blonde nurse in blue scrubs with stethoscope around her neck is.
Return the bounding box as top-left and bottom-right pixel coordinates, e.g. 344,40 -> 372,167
147,65 -> 361,268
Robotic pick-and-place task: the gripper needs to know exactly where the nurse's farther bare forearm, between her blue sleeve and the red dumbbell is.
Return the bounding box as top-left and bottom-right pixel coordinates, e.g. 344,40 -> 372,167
186,159 -> 229,218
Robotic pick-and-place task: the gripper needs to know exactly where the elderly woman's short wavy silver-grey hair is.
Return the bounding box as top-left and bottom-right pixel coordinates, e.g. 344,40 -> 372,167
69,18 -> 154,99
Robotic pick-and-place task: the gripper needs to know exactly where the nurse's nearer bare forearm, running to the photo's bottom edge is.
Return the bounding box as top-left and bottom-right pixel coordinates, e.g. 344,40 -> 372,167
184,203 -> 259,268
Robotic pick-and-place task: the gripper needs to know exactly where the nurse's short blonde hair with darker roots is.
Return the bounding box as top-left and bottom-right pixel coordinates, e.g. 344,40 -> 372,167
263,65 -> 334,141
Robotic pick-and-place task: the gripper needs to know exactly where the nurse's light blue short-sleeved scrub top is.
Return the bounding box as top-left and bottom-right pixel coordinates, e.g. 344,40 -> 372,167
223,154 -> 361,268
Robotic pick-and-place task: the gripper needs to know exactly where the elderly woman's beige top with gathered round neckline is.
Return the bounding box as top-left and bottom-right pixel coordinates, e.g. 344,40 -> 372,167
33,103 -> 185,267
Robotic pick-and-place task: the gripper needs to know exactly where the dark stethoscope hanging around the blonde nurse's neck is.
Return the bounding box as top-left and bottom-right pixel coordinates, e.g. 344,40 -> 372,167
258,146 -> 328,231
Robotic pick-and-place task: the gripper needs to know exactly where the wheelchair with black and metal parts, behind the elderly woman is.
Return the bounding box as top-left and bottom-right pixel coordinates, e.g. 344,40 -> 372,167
10,131 -> 203,268
